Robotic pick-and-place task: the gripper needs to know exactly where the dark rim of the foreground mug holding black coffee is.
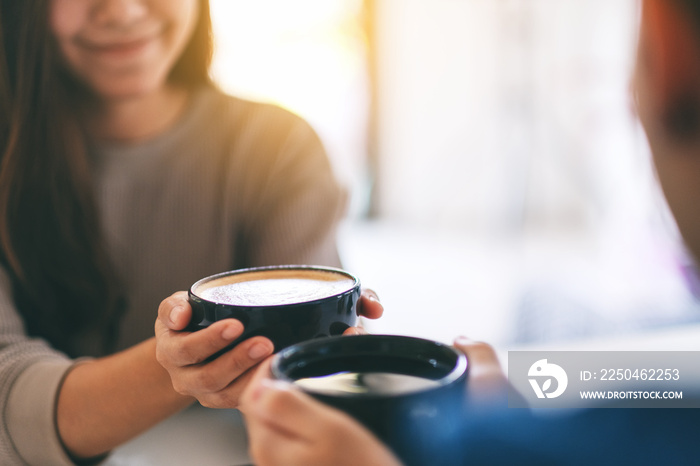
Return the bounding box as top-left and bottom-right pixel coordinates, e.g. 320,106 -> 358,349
270,334 -> 469,399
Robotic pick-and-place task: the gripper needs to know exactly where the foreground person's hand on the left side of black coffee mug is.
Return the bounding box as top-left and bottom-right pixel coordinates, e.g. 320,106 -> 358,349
240,359 -> 401,466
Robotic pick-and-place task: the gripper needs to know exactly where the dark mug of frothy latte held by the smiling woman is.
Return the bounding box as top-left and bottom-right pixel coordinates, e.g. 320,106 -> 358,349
188,265 -> 360,351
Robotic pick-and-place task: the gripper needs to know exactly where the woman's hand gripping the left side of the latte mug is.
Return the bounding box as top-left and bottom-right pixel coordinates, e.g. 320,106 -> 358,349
155,291 -> 274,408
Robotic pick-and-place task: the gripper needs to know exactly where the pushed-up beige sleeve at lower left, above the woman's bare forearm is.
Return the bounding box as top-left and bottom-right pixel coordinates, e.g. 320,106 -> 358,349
0,269 -> 73,465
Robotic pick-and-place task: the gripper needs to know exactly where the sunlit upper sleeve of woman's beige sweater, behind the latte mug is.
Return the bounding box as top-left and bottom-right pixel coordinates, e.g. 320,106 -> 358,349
231,103 -> 346,267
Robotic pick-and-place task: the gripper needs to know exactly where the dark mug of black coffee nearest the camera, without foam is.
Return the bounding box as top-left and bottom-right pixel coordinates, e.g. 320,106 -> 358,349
271,335 -> 468,465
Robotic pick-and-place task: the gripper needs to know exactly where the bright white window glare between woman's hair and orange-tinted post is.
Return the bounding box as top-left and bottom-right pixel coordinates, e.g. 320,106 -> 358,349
210,0 -> 369,210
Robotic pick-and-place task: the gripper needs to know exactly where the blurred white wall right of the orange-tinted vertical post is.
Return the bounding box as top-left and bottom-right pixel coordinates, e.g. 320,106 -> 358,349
376,0 -> 656,237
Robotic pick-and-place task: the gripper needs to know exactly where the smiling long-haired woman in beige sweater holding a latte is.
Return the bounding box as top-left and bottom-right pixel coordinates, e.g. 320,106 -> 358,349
0,0 -> 381,464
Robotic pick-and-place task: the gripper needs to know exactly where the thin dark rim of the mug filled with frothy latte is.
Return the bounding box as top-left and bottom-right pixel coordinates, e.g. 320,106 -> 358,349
188,264 -> 360,309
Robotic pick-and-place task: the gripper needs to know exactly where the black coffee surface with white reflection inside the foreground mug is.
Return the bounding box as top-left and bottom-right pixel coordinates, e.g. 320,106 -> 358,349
294,372 -> 440,395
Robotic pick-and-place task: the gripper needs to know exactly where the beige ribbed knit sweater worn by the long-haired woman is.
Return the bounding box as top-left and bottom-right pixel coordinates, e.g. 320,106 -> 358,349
0,88 -> 344,465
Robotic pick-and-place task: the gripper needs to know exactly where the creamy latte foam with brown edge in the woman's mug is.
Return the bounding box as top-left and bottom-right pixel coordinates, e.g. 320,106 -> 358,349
195,269 -> 355,306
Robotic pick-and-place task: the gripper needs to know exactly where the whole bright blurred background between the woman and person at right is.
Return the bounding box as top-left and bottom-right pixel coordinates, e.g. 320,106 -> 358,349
206,0 -> 700,349
